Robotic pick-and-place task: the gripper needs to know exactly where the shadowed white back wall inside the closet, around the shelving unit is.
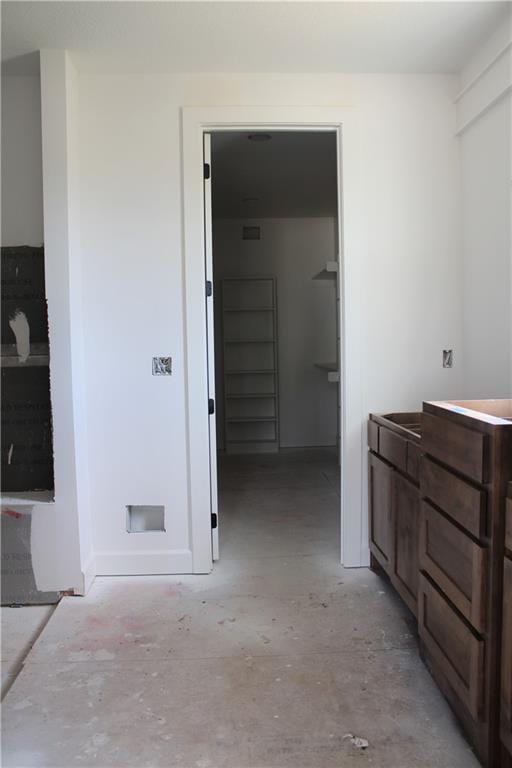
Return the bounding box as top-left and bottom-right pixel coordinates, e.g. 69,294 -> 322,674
213,218 -> 338,448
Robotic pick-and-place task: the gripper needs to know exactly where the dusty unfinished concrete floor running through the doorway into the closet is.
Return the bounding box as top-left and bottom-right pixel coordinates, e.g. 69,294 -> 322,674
2,450 -> 478,768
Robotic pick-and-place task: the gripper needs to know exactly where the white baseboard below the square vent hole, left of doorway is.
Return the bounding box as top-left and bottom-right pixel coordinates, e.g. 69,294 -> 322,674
95,549 -> 192,576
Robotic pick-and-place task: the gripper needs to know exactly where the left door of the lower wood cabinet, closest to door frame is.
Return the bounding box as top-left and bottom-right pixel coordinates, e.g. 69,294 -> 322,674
368,453 -> 393,571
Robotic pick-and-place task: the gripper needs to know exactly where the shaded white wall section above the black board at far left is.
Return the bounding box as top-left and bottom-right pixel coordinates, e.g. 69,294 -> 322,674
2,75 -> 43,246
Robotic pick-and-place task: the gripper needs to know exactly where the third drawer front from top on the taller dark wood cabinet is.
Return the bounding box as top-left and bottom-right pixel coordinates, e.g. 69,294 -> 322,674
419,502 -> 487,632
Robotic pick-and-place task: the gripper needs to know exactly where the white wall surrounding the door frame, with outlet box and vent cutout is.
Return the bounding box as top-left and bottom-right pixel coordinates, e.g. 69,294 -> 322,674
79,74 -> 462,572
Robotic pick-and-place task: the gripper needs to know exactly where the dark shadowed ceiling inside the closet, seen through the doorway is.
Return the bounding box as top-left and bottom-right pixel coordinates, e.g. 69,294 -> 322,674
212,131 -> 337,219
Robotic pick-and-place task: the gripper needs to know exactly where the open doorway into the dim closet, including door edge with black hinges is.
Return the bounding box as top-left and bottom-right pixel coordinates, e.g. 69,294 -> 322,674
205,130 -> 341,562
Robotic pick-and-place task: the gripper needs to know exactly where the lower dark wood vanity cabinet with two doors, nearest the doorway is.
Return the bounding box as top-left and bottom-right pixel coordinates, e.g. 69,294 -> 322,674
368,413 -> 421,616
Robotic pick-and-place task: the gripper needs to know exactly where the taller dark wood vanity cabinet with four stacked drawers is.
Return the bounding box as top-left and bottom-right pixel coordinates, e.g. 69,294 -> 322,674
418,401 -> 512,768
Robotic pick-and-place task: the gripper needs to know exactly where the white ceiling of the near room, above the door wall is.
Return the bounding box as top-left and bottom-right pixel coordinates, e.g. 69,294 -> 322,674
2,0 -> 510,73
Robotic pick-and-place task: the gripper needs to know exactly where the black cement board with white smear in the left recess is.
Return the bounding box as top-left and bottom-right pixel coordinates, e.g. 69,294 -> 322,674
1,246 -> 54,492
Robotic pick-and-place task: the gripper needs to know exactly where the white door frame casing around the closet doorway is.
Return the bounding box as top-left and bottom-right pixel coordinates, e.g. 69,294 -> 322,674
182,106 -> 369,573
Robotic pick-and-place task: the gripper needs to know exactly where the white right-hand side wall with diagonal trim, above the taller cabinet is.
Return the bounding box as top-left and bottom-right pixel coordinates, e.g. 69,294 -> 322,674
457,10 -> 512,399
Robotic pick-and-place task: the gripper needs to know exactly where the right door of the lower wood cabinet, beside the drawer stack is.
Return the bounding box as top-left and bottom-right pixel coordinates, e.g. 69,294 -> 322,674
391,472 -> 420,616
